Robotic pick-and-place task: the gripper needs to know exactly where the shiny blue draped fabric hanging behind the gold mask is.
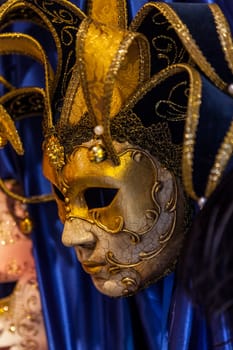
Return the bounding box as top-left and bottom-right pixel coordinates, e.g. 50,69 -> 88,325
0,0 -> 233,350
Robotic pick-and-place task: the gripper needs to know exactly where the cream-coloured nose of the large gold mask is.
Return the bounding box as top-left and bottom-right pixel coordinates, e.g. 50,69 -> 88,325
62,218 -> 96,249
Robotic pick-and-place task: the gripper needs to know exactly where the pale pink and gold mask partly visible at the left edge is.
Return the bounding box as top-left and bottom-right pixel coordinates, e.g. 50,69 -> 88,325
0,181 -> 47,350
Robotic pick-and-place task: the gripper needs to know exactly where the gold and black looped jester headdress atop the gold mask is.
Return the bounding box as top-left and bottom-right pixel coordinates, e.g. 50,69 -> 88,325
0,0 -> 233,199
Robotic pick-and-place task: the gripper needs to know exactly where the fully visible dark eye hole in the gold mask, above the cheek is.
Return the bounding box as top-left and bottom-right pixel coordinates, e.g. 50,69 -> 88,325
84,187 -> 118,209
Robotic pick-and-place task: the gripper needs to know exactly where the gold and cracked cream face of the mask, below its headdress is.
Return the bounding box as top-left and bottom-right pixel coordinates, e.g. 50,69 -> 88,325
46,142 -> 184,296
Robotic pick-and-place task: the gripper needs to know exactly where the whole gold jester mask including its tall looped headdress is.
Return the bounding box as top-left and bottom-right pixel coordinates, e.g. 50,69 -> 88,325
0,0 -> 232,296
